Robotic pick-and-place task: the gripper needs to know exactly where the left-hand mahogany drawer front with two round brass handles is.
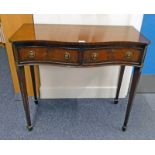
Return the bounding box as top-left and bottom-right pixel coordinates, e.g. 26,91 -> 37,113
18,47 -> 78,63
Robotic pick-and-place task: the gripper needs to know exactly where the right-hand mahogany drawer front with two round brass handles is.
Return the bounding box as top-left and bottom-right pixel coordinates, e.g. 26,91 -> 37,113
84,48 -> 142,64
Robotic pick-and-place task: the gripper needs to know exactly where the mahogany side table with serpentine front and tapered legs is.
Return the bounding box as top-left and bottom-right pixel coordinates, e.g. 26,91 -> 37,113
10,24 -> 150,131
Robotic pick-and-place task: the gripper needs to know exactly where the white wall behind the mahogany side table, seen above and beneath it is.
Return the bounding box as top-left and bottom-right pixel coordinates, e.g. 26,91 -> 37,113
34,14 -> 143,98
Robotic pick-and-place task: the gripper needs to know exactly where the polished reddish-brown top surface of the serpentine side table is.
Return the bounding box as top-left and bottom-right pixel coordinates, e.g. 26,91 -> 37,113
10,24 -> 149,44
